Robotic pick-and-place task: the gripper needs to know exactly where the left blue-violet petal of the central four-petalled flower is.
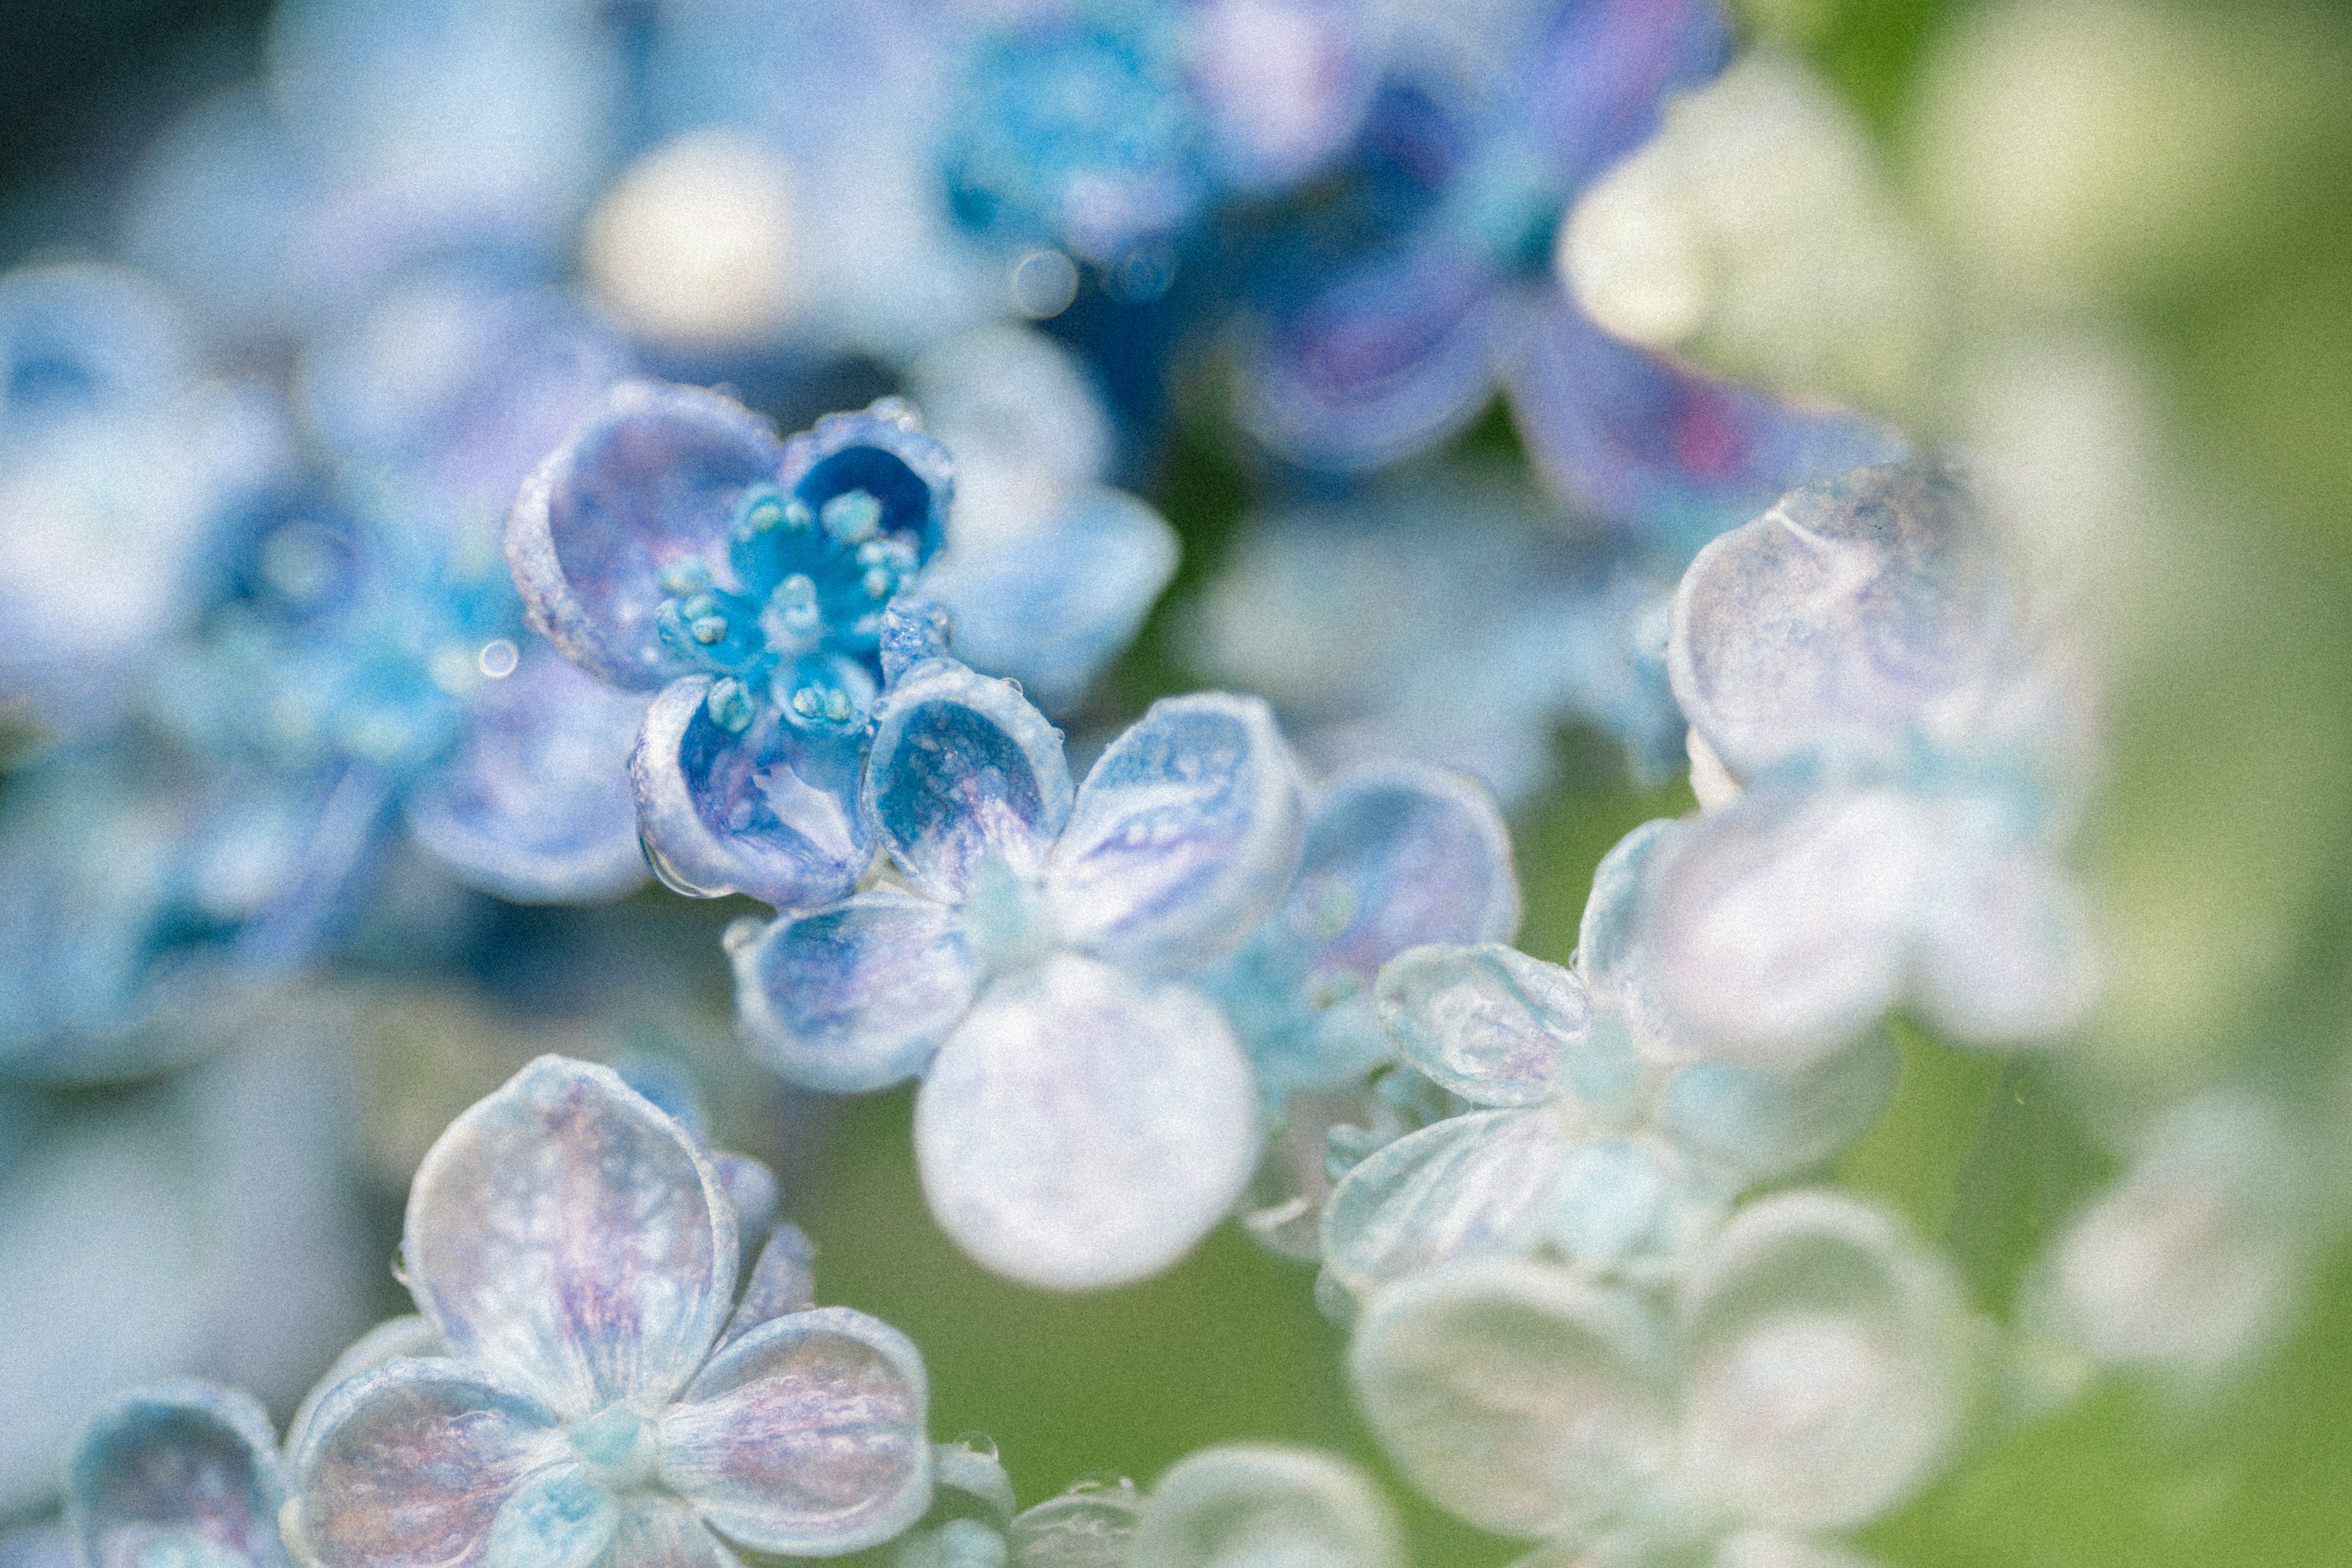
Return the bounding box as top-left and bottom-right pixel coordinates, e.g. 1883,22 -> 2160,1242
729,893 -> 981,1093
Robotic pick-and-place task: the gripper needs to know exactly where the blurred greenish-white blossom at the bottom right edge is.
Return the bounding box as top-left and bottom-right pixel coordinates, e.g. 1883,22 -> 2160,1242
1348,1192 -> 1971,1568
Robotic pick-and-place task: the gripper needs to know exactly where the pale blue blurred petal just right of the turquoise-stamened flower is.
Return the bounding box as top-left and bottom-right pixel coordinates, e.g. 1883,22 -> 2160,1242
922,486 -> 1178,712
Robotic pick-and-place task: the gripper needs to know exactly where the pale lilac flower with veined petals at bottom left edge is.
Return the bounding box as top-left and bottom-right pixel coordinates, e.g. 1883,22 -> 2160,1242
285,1058 -> 932,1568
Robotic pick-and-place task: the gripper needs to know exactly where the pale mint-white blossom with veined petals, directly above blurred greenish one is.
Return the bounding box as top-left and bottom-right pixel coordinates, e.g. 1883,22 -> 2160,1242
1324,823 -> 1896,1298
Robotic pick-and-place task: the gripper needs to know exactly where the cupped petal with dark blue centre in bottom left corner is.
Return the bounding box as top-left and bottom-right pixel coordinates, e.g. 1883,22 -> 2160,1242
66,1382 -> 287,1568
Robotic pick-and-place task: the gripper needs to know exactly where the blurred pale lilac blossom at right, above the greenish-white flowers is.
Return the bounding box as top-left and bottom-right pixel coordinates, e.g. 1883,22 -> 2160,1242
1646,453 -> 2094,1065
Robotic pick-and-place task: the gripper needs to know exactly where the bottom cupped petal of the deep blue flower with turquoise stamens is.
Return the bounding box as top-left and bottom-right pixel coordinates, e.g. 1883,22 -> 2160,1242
628,675 -> 875,910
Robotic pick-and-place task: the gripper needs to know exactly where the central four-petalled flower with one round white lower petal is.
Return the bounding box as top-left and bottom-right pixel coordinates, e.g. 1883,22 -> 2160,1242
729,658 -> 1303,1288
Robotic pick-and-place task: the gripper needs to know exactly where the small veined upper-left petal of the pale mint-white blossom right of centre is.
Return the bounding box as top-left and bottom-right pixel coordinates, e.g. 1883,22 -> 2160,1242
1374,943 -> 1593,1105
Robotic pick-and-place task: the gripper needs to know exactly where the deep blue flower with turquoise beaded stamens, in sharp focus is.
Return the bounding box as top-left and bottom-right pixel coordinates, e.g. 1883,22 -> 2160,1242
506,381 -> 950,907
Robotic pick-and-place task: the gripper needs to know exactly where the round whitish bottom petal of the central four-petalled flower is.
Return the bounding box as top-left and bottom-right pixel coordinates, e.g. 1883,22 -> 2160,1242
915,954 -> 1261,1291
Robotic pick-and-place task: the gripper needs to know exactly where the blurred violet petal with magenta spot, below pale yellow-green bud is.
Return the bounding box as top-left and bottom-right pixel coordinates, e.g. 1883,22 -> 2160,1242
1506,298 -> 1903,552
